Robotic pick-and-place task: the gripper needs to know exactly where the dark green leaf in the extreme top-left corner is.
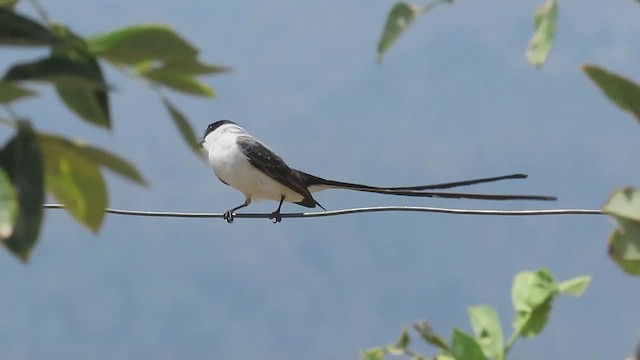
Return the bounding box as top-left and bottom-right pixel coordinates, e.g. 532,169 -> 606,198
0,8 -> 58,46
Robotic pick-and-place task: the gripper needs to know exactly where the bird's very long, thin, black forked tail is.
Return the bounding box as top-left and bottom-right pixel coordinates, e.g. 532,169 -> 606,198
298,171 -> 557,201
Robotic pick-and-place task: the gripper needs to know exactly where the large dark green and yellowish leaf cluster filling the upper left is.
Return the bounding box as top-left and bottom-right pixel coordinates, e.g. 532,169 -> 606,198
0,0 -> 229,261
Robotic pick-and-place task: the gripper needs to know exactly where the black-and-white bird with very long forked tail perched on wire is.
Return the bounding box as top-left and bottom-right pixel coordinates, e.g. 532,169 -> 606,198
200,120 -> 556,223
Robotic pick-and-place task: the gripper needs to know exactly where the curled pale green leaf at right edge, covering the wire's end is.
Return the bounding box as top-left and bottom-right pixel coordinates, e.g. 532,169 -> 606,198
602,188 -> 640,276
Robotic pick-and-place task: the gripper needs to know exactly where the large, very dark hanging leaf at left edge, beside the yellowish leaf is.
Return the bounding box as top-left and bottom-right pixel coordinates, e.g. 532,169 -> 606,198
0,123 -> 44,262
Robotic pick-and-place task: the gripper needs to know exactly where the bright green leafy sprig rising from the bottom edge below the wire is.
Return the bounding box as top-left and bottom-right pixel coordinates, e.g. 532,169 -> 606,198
361,269 -> 591,360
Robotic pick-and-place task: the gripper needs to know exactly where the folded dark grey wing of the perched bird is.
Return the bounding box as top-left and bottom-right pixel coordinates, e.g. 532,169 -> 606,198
236,136 -> 319,207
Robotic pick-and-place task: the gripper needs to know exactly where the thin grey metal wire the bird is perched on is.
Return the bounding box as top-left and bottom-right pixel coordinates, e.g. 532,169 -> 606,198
44,204 -> 604,219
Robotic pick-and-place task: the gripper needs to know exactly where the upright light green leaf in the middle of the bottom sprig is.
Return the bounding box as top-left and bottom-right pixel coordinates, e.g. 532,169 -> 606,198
467,305 -> 504,360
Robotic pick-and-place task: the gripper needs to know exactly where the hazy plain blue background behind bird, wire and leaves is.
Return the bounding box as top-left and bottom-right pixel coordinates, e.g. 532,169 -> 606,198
0,0 -> 640,359
